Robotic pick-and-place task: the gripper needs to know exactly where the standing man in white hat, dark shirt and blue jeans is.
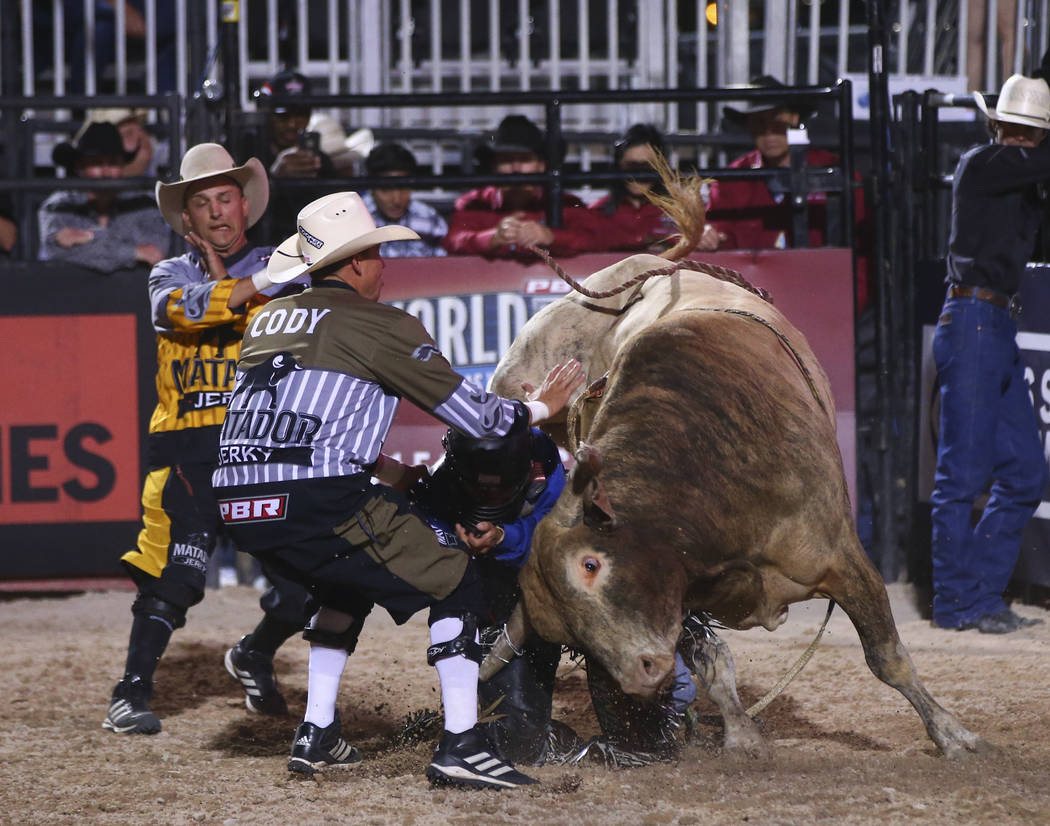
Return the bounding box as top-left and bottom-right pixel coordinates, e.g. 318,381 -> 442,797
930,75 -> 1050,634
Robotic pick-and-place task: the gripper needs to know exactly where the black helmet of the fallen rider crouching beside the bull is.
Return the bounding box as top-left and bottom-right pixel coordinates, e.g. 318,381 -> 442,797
441,417 -> 532,525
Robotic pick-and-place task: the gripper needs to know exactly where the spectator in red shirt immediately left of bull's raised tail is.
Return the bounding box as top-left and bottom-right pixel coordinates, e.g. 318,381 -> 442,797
590,124 -> 675,250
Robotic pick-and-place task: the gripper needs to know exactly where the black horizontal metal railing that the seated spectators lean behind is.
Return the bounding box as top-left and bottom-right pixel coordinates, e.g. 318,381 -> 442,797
0,82 -> 855,260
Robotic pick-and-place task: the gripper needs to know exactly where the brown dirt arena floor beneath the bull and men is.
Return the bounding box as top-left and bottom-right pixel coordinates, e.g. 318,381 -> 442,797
0,586 -> 1050,826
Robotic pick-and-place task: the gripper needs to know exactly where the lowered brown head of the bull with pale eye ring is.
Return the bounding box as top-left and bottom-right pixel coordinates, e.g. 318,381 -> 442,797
482,445 -> 685,698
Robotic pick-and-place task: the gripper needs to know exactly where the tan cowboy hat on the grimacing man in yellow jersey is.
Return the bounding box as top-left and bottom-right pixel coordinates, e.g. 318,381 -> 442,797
156,144 -> 270,235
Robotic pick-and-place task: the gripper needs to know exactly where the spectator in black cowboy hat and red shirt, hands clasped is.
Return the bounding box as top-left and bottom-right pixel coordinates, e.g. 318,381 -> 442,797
444,114 -> 602,259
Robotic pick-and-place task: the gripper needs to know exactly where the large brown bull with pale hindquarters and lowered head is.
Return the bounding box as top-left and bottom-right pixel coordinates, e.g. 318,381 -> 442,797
483,255 -> 982,757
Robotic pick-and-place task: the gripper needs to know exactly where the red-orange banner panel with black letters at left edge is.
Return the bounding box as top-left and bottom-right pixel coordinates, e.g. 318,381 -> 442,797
0,315 -> 140,525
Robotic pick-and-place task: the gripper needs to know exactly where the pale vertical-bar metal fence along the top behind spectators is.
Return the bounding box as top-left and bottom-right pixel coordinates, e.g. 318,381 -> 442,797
6,0 -> 1050,139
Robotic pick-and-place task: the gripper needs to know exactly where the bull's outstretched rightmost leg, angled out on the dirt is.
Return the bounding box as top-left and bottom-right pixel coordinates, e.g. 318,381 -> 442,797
821,537 -> 985,758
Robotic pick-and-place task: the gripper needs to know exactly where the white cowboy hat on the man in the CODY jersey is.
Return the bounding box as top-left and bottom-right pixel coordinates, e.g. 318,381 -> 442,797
266,192 -> 419,284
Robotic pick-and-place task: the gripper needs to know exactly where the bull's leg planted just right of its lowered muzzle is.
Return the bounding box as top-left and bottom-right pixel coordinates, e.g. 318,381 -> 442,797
678,615 -> 769,758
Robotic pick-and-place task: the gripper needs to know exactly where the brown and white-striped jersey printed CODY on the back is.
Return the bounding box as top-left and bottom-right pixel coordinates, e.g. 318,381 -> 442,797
212,280 -> 527,487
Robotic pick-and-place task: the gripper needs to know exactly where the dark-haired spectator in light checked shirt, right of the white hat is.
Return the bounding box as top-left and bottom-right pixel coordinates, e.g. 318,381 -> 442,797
363,144 -> 448,258
